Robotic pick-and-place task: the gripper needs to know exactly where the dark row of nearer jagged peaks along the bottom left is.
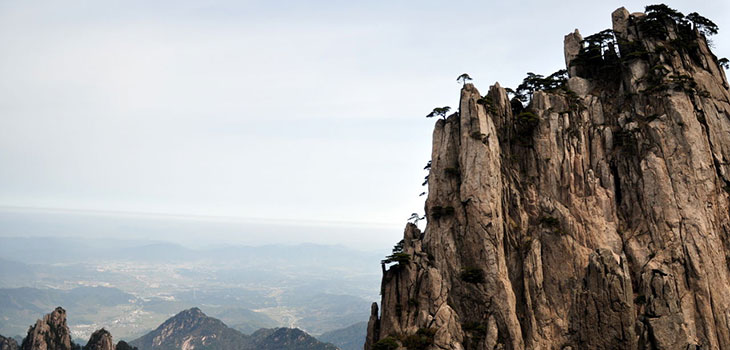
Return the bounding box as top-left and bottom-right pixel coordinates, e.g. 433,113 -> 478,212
0,307 -> 339,350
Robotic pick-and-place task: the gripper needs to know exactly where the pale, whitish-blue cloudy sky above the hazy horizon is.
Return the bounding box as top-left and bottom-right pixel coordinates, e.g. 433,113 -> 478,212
0,0 -> 730,244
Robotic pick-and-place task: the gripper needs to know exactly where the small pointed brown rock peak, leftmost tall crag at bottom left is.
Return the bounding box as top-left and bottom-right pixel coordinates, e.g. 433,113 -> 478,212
21,307 -> 72,350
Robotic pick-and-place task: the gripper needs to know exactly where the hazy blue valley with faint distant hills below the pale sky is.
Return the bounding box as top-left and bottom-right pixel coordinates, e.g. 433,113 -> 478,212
0,206 -> 385,346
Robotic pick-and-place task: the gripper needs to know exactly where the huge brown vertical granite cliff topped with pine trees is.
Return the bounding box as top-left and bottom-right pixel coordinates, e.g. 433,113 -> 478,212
365,8 -> 730,350
